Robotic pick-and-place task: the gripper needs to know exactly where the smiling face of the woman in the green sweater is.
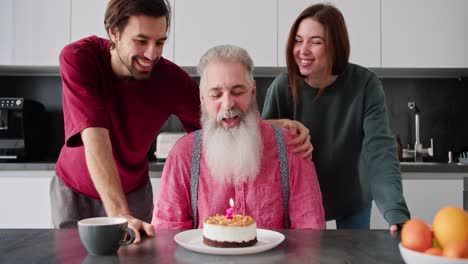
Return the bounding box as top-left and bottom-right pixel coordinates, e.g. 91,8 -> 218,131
293,18 -> 329,80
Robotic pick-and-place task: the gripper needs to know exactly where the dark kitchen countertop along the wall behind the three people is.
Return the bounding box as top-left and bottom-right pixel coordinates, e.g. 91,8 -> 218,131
0,162 -> 468,174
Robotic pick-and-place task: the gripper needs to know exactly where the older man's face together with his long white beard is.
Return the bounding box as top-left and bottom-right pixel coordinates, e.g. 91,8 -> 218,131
200,60 -> 263,184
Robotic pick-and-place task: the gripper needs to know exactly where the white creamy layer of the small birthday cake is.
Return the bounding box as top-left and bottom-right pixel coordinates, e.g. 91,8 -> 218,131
203,223 -> 257,242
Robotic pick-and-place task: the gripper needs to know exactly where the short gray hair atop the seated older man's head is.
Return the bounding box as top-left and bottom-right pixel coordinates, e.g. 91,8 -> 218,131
197,45 -> 254,88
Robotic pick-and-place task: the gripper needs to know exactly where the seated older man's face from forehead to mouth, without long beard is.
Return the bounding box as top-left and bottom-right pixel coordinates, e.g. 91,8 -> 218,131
200,61 -> 256,128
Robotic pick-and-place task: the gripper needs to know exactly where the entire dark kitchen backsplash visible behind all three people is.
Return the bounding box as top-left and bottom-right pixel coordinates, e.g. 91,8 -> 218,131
0,73 -> 468,162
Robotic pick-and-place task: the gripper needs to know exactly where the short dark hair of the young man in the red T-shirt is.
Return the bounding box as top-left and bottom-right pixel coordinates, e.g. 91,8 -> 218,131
104,0 -> 171,48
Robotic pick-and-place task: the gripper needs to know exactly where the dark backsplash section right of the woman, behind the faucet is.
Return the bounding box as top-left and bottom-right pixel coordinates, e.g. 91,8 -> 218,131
381,78 -> 468,161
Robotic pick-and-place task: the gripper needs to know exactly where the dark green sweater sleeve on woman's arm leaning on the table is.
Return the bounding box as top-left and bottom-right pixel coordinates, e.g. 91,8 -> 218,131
362,76 -> 410,225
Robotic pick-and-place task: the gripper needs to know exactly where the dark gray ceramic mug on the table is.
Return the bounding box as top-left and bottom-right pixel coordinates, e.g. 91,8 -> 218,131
78,217 -> 135,255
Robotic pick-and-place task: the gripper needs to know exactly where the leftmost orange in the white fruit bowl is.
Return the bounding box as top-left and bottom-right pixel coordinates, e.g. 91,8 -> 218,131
401,218 -> 432,252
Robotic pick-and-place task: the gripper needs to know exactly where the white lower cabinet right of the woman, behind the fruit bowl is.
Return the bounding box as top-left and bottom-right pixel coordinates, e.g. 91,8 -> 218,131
371,176 -> 463,229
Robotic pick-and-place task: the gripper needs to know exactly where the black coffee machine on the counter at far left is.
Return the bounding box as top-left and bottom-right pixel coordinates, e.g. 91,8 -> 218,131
0,98 -> 45,161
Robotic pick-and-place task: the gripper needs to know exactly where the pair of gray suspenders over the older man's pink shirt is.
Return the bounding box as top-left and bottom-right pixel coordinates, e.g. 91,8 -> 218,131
190,126 -> 290,229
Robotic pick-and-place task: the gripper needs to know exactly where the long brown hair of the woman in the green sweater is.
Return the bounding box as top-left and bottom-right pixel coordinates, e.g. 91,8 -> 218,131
286,4 -> 350,102
